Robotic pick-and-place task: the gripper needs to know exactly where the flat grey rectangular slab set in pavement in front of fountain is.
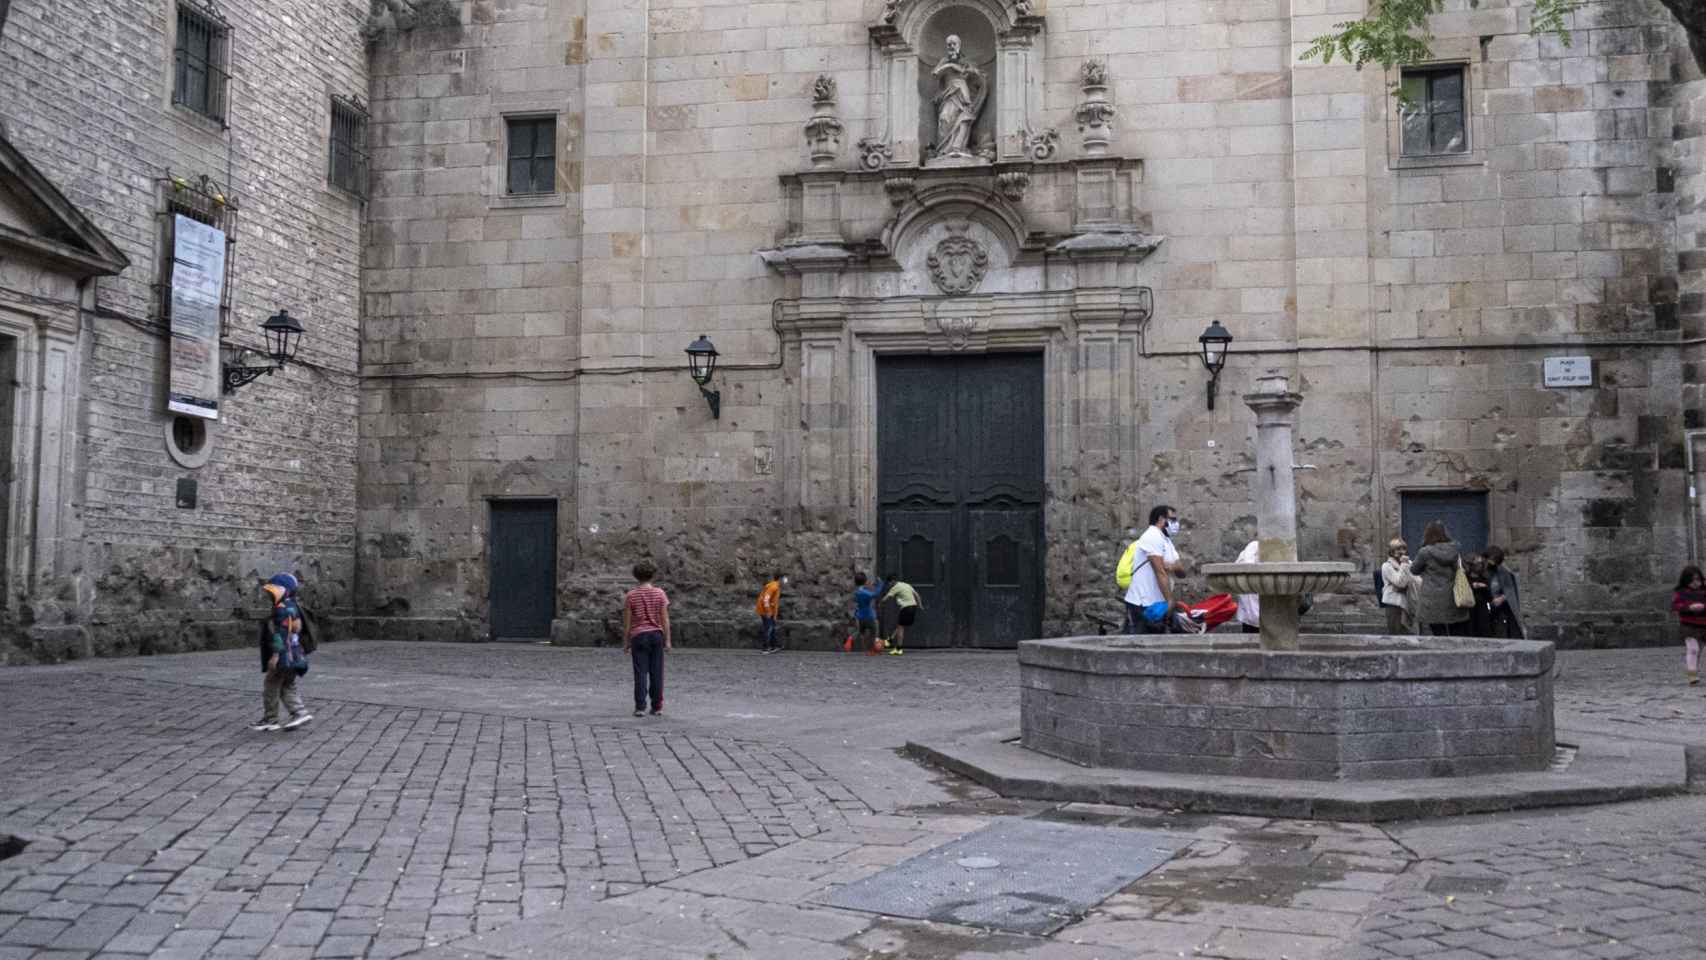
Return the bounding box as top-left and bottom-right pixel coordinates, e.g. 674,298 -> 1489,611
822,820 -> 1189,936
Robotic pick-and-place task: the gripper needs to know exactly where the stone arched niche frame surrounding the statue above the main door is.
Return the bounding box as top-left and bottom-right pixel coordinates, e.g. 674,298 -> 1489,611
870,0 -> 1044,167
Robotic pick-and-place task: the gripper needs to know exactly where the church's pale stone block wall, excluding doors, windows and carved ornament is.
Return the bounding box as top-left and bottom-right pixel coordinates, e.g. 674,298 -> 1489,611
349,0 -> 1697,645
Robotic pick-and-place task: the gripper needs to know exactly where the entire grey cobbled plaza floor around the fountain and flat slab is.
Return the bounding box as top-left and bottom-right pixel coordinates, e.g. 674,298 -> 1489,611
0,643 -> 1706,960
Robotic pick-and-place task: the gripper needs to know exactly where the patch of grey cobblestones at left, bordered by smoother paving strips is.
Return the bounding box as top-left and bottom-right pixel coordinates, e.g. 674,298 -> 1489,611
0,672 -> 865,958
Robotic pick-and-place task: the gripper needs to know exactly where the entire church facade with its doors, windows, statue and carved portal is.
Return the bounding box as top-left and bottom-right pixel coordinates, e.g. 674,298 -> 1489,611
0,0 -> 1706,661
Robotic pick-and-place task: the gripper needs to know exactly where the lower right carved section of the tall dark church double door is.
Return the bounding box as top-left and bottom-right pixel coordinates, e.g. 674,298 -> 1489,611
967,508 -> 1042,646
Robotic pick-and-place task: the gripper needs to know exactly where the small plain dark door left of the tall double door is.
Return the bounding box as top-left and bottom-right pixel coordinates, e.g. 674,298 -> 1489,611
488,500 -> 556,639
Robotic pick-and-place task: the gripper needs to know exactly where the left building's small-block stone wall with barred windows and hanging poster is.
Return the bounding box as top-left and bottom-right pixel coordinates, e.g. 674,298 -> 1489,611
0,0 -> 367,662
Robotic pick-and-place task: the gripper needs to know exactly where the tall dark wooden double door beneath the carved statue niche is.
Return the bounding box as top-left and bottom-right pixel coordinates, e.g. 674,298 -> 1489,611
873,353 -> 1044,646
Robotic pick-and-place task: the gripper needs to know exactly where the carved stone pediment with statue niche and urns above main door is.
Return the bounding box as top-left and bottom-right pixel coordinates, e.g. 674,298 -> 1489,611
761,0 -> 1160,284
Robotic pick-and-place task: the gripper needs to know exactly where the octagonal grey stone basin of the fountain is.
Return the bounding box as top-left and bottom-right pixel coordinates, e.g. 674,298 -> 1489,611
1018,634 -> 1556,779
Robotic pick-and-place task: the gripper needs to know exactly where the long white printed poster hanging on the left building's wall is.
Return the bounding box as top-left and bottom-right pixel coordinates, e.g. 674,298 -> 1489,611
165,213 -> 225,419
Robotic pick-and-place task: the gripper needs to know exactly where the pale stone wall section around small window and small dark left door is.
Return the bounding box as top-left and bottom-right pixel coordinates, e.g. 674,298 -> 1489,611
357,0 -> 586,639
